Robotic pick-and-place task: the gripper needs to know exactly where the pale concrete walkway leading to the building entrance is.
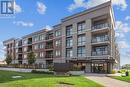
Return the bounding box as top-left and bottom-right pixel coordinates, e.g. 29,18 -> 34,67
86,73 -> 130,87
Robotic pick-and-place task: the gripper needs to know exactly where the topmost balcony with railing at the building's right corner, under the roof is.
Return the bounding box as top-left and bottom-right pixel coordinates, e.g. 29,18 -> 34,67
92,23 -> 111,31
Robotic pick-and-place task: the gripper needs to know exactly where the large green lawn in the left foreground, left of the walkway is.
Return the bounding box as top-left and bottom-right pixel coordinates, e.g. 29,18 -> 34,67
0,71 -> 103,87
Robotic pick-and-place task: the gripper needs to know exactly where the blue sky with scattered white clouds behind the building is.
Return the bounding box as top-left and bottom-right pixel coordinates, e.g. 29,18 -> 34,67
0,0 -> 130,65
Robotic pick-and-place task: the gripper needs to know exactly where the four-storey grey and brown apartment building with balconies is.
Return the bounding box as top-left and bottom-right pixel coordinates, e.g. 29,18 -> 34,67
3,2 -> 120,73
